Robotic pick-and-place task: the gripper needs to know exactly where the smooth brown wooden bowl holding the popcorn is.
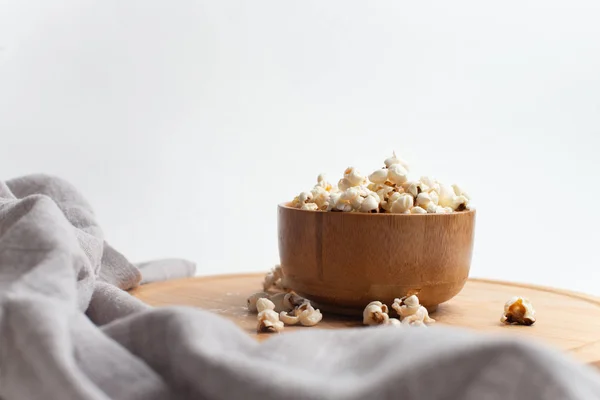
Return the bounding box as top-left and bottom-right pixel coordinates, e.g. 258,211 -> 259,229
278,203 -> 475,314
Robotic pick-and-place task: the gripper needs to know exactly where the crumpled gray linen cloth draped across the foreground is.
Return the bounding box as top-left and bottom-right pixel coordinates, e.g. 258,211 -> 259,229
0,175 -> 600,400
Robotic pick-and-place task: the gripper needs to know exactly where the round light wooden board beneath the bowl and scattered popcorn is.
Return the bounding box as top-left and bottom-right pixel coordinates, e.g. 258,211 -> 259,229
131,274 -> 600,368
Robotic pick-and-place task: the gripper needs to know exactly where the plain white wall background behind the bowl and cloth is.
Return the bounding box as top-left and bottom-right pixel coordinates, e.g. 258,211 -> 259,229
0,0 -> 600,294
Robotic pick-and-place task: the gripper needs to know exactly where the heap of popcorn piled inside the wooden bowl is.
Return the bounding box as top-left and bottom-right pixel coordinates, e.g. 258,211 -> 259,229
292,153 -> 473,214
